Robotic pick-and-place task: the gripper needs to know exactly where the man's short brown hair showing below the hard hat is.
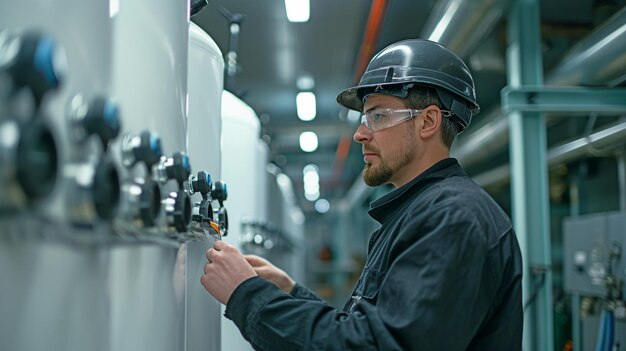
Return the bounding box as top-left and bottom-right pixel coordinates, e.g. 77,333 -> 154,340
406,85 -> 460,149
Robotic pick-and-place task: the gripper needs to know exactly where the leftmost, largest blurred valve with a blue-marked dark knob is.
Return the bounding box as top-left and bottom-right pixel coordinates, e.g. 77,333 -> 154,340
0,31 -> 64,210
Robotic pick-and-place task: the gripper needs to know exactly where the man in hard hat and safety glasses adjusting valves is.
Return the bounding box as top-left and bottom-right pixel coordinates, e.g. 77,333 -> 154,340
201,39 -> 523,351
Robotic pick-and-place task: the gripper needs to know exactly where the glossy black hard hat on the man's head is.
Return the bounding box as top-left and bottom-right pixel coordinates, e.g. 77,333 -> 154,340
337,39 -> 480,130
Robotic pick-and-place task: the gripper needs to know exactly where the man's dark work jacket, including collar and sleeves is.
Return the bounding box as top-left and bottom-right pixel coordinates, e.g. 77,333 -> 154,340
225,158 -> 523,351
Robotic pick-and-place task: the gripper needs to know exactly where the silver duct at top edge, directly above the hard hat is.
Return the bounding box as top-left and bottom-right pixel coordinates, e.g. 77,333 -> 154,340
420,0 -> 511,57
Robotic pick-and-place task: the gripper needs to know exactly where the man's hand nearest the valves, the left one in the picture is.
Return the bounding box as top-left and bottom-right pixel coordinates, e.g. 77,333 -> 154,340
200,240 -> 257,305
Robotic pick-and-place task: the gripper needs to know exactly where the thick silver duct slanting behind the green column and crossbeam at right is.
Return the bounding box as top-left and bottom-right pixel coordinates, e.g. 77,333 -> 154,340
453,7 -> 626,167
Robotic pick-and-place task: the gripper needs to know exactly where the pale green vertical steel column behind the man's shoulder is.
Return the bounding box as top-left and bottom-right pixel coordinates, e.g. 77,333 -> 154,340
507,0 -> 554,351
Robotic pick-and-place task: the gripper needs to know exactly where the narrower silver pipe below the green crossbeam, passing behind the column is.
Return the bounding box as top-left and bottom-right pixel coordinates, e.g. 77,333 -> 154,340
472,120 -> 626,187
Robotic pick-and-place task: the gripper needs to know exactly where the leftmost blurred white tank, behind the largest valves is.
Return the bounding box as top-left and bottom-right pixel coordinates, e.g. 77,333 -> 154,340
0,0 -> 111,351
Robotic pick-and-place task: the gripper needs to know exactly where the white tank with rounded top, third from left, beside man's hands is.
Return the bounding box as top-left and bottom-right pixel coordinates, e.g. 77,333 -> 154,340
186,22 -> 224,351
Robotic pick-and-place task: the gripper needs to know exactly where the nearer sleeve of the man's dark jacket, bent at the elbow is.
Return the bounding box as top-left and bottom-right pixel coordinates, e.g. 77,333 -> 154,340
225,209 -> 493,351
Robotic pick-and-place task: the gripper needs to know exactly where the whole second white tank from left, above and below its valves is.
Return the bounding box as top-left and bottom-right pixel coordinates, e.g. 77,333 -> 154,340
109,0 -> 193,351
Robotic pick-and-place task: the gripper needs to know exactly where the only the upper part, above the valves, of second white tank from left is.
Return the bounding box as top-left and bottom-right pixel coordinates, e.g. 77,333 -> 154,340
112,0 -> 189,155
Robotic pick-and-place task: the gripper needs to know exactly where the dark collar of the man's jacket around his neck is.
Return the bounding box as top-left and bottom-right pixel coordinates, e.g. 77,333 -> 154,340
368,158 -> 466,223
